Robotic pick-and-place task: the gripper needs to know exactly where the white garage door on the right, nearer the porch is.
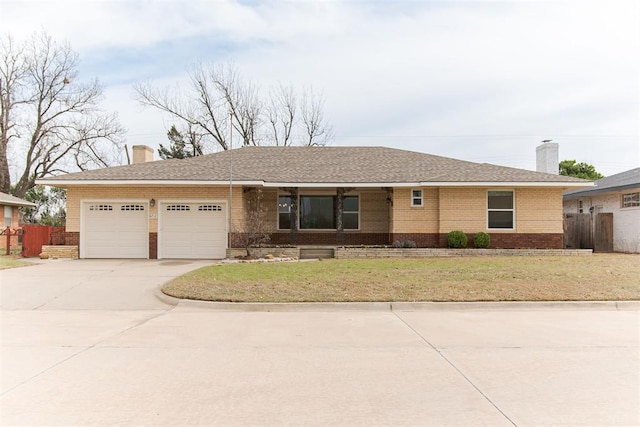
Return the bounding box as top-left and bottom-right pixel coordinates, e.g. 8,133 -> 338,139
158,202 -> 227,259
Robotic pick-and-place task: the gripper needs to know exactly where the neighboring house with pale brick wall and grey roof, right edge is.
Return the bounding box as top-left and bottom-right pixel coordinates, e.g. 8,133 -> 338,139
563,168 -> 640,253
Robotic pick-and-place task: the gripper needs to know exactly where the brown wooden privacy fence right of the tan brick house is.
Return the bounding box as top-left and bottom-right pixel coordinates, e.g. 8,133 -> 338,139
564,213 -> 613,252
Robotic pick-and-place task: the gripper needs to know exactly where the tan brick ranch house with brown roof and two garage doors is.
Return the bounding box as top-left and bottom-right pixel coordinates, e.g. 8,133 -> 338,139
38,146 -> 591,259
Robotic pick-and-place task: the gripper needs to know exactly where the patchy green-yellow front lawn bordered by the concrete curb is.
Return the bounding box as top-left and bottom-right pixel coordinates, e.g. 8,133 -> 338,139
162,254 -> 640,302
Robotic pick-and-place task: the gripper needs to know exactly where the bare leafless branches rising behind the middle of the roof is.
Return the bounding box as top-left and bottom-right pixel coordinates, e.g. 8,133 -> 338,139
134,64 -> 333,150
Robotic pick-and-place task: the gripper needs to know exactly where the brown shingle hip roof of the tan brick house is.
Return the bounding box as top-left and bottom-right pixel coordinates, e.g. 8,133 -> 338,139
40,147 -> 585,185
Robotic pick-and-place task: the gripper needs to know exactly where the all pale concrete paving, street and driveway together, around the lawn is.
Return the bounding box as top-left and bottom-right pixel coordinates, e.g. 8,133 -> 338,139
0,260 -> 640,426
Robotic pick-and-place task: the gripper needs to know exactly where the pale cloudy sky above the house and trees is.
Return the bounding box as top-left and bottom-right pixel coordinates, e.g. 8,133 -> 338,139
0,0 -> 640,175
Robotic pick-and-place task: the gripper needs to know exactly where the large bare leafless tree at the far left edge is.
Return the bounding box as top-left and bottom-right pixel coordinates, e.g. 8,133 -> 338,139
0,33 -> 124,197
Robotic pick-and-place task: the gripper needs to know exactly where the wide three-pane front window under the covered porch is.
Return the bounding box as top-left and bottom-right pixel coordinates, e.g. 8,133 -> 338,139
278,196 -> 360,230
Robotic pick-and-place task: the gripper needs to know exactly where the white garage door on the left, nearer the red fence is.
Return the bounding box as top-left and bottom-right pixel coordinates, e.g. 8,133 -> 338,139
80,202 -> 149,258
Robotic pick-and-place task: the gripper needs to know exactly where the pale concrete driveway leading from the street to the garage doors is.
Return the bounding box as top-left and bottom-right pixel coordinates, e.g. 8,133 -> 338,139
0,259 -> 211,310
